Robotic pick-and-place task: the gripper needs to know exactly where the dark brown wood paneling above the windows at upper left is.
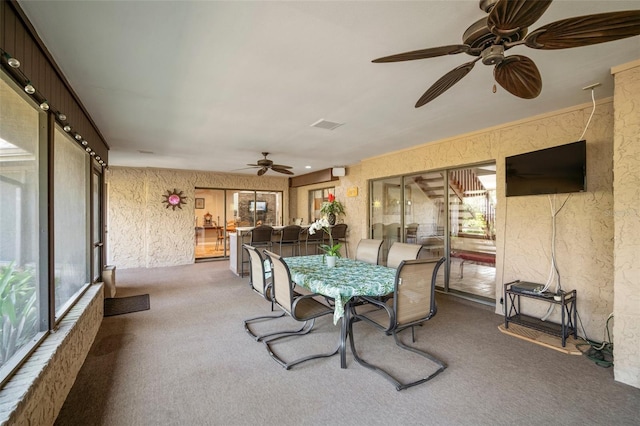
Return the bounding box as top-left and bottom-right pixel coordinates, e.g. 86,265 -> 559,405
0,0 -> 109,161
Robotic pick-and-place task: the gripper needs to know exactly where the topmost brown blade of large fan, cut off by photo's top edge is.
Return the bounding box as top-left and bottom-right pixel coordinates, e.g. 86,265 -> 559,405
487,0 -> 551,36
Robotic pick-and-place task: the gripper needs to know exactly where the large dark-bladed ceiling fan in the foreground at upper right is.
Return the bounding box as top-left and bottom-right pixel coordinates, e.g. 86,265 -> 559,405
373,0 -> 640,108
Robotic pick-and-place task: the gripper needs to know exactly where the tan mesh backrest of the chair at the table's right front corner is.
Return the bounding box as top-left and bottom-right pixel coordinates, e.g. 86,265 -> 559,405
393,258 -> 444,328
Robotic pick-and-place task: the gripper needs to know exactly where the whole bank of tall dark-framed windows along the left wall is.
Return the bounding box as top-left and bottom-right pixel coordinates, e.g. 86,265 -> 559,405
0,71 -> 95,384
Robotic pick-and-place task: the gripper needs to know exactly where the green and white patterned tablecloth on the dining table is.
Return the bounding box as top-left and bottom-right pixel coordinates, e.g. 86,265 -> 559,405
284,255 -> 396,324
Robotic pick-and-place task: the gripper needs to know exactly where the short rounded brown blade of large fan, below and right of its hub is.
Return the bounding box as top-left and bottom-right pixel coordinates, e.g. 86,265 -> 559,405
493,55 -> 542,99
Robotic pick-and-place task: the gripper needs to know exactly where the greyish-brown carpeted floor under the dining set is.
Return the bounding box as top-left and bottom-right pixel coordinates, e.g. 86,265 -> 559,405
56,262 -> 640,426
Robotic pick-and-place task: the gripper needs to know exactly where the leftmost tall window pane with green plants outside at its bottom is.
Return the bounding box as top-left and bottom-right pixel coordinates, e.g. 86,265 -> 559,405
0,73 -> 47,379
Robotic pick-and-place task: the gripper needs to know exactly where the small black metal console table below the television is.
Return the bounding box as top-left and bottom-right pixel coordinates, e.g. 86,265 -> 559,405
504,281 -> 578,347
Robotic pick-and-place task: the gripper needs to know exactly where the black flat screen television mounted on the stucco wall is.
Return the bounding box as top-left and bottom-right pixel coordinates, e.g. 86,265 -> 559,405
505,140 -> 587,197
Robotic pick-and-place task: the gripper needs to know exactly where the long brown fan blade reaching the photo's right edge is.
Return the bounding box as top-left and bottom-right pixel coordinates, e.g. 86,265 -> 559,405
524,10 -> 640,50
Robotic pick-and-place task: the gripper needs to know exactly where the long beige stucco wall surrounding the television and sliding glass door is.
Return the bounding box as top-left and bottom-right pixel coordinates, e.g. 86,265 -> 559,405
297,99 -> 614,348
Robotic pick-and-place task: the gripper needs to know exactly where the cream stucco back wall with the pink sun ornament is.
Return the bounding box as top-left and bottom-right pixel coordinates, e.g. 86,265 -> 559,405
107,167 -> 289,268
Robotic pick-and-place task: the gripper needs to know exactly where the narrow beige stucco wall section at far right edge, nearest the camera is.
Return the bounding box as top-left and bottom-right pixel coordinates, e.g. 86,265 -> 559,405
613,60 -> 640,388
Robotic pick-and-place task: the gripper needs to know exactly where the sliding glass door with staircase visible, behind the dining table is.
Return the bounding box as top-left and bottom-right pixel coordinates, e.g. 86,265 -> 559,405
369,163 -> 496,300
